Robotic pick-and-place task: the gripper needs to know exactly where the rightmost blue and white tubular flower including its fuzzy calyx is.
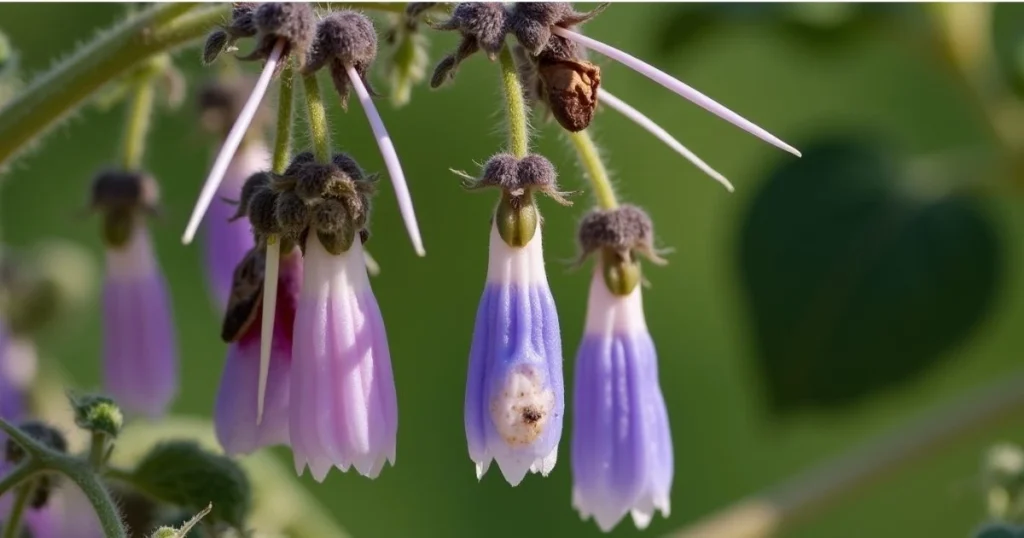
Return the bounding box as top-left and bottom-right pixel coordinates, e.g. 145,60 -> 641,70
572,206 -> 673,532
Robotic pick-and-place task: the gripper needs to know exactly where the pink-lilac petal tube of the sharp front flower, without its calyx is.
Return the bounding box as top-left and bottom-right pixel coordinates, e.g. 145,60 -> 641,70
290,234 -> 398,482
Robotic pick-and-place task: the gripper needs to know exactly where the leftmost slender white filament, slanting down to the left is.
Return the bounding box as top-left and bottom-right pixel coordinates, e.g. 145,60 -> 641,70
181,40 -> 285,245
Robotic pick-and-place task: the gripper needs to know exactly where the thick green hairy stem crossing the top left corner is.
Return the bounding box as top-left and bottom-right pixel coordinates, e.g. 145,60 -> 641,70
0,3 -> 224,164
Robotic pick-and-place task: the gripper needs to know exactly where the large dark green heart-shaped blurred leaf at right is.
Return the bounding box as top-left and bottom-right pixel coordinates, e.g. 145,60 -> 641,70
738,138 -> 1002,413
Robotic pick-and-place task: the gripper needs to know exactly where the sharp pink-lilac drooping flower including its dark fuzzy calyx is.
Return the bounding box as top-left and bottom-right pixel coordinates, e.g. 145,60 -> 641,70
241,153 -> 398,481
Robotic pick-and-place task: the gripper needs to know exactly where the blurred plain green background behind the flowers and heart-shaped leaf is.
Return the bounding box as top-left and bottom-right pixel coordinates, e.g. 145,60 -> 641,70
0,4 -> 1024,538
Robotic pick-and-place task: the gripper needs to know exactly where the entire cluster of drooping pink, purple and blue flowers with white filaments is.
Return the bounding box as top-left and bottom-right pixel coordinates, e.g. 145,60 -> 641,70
0,2 -> 799,532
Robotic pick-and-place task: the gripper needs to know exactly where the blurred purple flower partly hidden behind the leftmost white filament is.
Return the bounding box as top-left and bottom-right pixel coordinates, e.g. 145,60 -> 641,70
205,140 -> 270,311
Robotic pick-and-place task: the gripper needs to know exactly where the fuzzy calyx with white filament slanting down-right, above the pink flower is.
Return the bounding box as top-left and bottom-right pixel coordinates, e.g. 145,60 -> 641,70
304,10 -> 426,256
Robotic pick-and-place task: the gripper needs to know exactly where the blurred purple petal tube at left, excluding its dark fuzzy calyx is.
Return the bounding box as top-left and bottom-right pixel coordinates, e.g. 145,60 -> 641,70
103,224 -> 178,418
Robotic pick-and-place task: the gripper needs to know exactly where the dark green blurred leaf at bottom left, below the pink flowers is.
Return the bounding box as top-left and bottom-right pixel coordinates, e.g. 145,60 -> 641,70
130,441 -> 252,530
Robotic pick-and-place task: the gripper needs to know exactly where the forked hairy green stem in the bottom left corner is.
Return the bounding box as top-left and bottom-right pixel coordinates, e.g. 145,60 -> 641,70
0,419 -> 128,538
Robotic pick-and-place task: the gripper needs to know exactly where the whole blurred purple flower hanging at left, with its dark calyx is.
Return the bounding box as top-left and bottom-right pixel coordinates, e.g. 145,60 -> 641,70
92,170 -> 178,418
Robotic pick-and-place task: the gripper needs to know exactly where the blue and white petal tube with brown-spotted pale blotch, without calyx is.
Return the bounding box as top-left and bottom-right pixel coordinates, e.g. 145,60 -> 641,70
465,222 -> 564,486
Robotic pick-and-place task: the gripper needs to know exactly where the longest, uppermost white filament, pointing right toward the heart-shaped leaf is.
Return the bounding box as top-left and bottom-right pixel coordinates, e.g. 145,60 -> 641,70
551,26 -> 801,157
